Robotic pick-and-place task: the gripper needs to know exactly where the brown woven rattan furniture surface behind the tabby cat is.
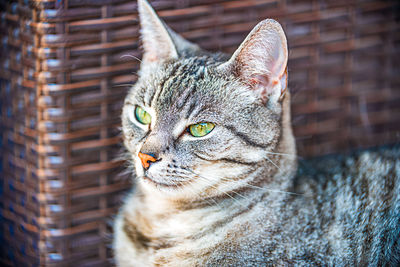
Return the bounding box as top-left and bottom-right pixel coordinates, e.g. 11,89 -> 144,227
0,0 -> 400,267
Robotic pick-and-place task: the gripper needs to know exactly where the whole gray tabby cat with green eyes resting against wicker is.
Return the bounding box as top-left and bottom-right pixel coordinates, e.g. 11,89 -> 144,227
113,0 -> 400,266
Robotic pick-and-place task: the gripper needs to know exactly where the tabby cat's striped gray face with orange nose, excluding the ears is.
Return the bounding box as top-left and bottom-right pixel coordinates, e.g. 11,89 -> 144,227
123,59 -> 280,198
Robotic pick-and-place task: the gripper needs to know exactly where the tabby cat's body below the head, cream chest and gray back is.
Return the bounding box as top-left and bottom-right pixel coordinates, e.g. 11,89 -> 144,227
114,147 -> 400,266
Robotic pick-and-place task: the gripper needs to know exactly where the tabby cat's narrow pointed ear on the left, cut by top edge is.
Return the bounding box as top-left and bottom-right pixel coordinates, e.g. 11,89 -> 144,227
138,0 -> 200,63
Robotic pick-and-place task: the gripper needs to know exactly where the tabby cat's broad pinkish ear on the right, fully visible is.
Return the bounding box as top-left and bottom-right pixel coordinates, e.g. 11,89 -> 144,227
219,19 -> 288,104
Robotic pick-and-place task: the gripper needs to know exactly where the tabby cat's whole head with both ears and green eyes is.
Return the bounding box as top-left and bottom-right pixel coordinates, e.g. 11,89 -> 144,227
122,0 -> 294,200
